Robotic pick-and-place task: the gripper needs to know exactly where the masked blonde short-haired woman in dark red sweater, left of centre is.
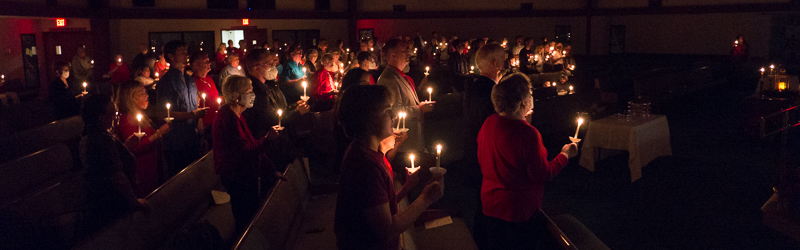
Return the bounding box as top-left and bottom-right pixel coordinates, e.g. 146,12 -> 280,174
212,75 -> 287,232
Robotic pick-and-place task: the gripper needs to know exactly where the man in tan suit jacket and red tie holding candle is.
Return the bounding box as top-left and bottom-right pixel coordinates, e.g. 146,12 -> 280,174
378,39 -> 433,152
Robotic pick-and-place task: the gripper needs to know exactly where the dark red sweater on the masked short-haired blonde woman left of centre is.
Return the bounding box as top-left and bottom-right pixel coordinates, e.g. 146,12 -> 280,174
212,104 -> 275,181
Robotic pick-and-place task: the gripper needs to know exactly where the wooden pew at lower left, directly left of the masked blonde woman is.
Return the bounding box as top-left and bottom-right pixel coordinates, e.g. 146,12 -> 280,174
73,151 -> 234,249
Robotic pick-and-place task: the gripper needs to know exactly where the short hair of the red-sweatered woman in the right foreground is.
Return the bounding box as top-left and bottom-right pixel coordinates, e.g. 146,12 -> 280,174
492,73 -> 531,113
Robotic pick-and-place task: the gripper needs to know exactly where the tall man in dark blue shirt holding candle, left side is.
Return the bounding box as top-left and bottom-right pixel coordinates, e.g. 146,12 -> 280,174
156,40 -> 208,176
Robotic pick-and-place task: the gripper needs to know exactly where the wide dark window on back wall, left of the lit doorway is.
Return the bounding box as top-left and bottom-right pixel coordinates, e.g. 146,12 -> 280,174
149,31 -> 216,55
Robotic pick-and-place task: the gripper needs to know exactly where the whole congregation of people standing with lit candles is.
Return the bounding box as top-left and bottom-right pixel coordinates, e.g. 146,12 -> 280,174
37,32 -> 577,249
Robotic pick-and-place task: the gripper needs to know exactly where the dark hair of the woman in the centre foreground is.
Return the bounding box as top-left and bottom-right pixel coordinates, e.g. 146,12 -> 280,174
337,85 -> 391,139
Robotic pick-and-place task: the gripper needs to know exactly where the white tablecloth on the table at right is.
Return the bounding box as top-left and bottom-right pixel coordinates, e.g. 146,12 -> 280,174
580,115 -> 672,181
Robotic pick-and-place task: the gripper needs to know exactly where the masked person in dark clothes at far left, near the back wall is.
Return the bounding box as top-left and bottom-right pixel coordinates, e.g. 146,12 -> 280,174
48,61 -> 83,120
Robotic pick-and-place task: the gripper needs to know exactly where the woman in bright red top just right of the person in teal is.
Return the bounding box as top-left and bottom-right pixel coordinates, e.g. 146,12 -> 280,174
309,54 -> 339,112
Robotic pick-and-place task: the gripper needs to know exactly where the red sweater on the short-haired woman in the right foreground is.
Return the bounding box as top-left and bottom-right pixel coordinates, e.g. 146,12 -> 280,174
478,114 -> 567,222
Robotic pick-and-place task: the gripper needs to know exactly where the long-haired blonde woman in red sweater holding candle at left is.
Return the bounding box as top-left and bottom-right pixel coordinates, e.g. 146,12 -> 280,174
116,80 -> 170,198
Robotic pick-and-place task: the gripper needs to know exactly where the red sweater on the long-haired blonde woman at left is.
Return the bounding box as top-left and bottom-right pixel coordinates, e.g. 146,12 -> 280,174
118,114 -> 160,198
